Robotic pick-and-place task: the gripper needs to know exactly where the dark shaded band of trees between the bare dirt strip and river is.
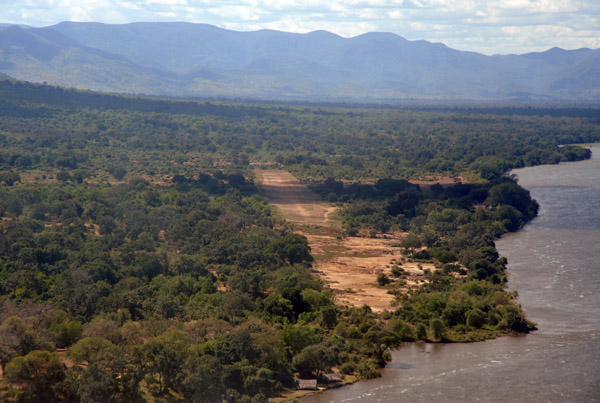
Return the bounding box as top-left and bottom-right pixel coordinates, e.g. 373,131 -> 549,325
310,177 -> 538,234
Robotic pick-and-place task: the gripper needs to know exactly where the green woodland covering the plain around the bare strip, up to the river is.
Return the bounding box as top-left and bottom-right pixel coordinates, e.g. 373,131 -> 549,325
0,80 -> 600,402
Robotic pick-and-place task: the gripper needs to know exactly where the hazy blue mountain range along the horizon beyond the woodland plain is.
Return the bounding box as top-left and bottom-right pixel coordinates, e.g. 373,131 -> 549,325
0,22 -> 600,101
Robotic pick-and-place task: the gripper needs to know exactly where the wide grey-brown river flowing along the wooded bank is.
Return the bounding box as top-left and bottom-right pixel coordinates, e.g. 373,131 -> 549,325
302,147 -> 600,403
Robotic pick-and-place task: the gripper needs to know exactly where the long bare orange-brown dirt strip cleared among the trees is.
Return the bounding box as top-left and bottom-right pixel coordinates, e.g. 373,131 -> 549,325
255,169 -> 433,312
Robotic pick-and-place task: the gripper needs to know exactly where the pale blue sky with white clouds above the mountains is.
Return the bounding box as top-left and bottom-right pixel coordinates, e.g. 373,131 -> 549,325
0,0 -> 600,54
